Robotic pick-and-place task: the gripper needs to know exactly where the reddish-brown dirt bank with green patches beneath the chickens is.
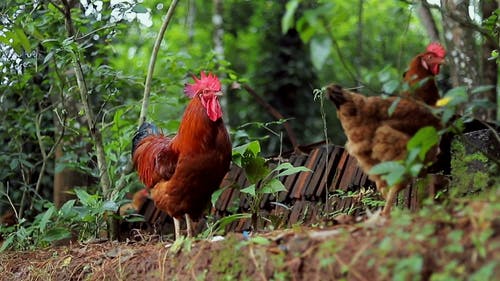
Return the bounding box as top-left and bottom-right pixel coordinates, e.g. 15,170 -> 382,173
0,197 -> 500,280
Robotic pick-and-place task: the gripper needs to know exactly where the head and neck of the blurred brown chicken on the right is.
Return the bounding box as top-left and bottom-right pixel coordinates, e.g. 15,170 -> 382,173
403,43 -> 446,106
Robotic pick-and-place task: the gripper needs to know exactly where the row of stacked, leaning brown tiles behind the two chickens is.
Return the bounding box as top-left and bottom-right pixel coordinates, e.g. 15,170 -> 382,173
135,145 -> 428,233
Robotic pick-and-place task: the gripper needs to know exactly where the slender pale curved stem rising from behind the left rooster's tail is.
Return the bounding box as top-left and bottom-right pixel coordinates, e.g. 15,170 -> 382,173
139,0 -> 177,126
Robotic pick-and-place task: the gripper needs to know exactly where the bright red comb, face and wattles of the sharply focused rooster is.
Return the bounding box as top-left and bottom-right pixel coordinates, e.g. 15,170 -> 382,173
184,71 -> 222,121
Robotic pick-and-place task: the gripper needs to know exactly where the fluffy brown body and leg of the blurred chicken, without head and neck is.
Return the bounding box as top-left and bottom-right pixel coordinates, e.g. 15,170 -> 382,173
326,85 -> 441,216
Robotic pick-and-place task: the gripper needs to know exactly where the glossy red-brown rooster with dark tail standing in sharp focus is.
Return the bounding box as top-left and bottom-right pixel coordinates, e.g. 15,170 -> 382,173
132,72 -> 232,239
